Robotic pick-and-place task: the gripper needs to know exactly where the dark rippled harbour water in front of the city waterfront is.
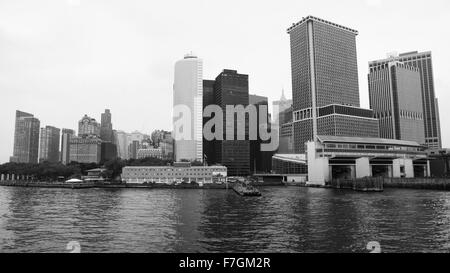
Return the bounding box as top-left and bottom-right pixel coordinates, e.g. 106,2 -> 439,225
0,187 -> 450,253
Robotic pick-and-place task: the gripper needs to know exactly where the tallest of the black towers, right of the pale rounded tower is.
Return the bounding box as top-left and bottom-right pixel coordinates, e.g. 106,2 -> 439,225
210,69 -> 250,176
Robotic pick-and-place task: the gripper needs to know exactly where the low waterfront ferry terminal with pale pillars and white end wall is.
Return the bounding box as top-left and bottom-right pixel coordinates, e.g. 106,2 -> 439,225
307,136 -> 430,185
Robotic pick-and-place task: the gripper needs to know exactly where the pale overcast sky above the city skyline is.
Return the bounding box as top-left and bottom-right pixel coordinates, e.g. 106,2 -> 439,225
0,0 -> 450,163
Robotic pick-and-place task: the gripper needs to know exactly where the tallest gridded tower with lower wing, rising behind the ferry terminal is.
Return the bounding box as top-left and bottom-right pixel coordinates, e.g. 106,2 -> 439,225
287,16 -> 379,153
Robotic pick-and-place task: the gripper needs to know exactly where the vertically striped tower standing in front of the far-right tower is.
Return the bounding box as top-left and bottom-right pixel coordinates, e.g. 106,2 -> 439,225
369,61 -> 425,144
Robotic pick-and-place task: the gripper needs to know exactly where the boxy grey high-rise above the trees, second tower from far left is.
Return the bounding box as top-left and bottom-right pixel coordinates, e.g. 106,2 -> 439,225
39,126 -> 61,163
